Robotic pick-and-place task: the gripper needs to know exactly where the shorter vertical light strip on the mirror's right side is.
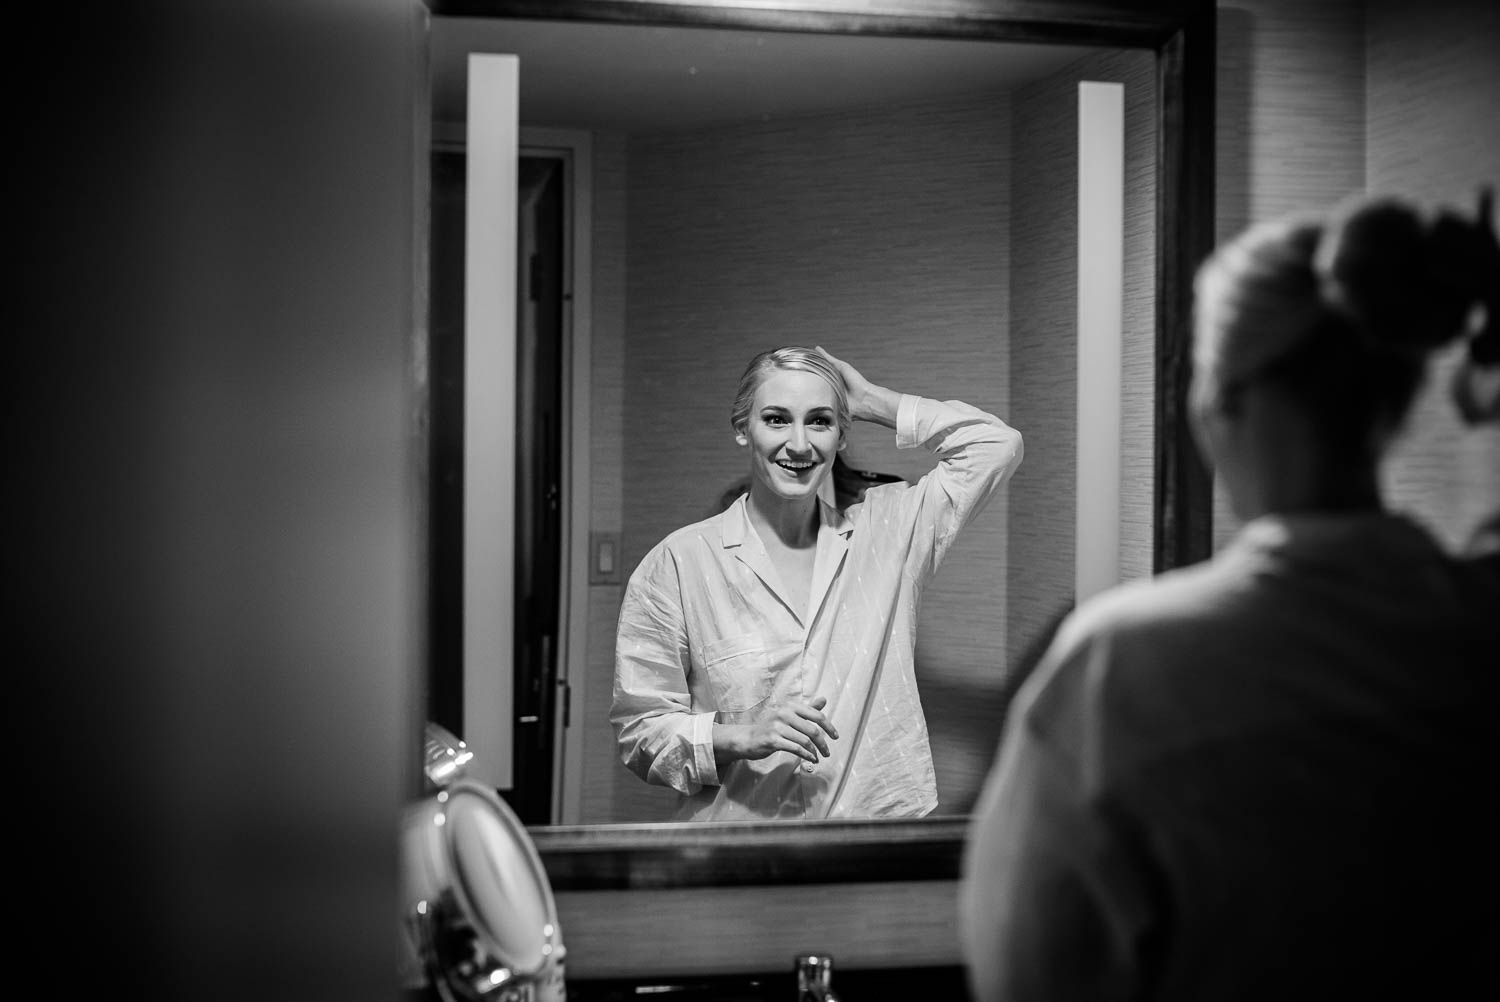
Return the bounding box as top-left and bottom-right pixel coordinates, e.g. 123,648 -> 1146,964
1074,83 -> 1125,603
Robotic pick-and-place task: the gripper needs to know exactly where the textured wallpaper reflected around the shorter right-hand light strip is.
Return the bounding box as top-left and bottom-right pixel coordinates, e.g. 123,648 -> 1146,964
1008,51 -> 1157,711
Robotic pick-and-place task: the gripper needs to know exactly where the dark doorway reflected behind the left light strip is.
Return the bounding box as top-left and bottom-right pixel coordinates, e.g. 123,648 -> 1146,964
426,147 -> 570,825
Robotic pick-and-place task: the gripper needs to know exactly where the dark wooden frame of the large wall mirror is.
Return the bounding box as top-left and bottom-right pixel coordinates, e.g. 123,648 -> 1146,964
423,0 -> 1217,891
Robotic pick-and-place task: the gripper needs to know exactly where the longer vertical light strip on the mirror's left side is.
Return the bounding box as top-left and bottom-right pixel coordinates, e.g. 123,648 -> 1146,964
464,56 -> 521,789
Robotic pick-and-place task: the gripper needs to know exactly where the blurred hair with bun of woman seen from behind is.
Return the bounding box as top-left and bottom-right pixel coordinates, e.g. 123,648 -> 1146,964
1194,192 -> 1500,450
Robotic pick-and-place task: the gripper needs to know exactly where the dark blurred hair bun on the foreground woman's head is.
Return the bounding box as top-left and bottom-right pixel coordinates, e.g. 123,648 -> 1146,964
1313,200 -> 1479,354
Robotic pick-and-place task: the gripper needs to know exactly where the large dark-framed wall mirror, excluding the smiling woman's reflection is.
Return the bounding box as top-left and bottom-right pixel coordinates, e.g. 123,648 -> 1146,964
428,0 -> 1214,887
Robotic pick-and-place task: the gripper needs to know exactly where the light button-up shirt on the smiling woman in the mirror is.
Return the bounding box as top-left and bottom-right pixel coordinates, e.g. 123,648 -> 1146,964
611,395 -> 1022,821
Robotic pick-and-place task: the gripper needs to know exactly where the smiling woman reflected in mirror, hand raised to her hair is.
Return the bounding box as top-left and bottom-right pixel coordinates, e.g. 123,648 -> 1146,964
611,348 -> 1022,821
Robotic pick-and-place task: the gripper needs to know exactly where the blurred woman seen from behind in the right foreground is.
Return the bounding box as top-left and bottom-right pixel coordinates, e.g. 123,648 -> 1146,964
960,192 -> 1500,1001
